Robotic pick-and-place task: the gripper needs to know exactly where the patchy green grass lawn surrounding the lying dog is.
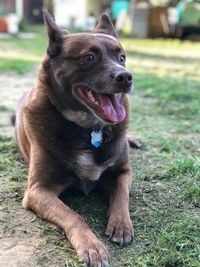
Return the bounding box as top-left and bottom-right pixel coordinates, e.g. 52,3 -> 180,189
0,30 -> 200,267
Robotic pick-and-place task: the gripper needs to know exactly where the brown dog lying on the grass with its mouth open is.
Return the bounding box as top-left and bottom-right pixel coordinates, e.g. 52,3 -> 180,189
16,12 -> 133,267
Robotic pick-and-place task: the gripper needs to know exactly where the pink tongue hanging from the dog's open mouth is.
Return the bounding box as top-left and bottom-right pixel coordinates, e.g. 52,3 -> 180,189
95,94 -> 126,123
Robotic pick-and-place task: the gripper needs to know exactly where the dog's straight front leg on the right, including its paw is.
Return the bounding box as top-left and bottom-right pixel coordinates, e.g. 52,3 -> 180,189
106,166 -> 133,246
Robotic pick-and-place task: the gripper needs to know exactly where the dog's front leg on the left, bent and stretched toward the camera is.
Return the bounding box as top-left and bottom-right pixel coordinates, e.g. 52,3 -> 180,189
23,151 -> 110,267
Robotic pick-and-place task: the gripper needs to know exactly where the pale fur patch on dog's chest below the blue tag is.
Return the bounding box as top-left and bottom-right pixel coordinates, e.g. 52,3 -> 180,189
75,151 -> 114,181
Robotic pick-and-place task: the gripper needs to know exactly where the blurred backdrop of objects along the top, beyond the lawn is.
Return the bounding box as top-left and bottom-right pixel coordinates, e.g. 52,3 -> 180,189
0,0 -> 200,39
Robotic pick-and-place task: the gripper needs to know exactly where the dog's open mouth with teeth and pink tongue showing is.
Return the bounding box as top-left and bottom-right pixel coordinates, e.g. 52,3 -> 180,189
73,84 -> 126,123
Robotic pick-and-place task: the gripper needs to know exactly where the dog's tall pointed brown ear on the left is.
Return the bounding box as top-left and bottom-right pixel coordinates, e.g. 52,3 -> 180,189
43,10 -> 66,56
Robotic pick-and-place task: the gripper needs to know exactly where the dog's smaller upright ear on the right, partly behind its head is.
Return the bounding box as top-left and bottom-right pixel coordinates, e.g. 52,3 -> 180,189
93,14 -> 118,38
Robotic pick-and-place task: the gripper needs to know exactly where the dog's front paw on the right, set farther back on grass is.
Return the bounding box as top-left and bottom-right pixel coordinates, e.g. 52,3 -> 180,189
106,214 -> 133,246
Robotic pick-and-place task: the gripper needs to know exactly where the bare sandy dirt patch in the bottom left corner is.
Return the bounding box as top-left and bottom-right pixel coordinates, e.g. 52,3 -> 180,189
0,193 -> 41,267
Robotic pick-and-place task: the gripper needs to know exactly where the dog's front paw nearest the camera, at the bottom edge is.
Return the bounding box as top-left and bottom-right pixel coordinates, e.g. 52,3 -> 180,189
77,240 -> 110,267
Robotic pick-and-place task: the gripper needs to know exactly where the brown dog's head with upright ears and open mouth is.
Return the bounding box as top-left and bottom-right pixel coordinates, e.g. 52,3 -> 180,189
44,12 -> 133,127
